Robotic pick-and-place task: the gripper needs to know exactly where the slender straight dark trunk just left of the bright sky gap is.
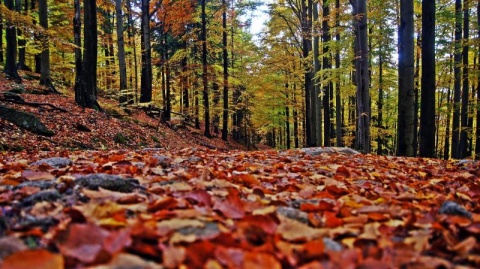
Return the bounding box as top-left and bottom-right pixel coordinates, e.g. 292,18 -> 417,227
222,0 -> 228,141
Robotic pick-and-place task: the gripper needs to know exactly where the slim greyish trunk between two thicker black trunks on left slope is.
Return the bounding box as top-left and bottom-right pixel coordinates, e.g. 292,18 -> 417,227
115,0 -> 131,106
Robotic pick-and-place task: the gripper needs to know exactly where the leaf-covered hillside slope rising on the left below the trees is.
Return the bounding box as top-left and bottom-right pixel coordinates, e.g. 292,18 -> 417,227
0,73 -> 245,151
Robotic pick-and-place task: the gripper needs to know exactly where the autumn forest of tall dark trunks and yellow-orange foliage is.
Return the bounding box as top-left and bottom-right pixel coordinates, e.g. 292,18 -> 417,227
0,0 -> 480,159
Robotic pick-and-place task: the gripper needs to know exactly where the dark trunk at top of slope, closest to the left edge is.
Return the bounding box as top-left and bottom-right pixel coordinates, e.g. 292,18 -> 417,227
3,0 -> 22,83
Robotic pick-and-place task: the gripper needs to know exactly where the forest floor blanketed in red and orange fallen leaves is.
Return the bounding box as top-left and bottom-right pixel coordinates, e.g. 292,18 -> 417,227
0,72 -> 480,269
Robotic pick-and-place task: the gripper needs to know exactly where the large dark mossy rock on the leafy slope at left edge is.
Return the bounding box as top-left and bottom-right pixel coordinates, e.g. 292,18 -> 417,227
0,106 -> 55,136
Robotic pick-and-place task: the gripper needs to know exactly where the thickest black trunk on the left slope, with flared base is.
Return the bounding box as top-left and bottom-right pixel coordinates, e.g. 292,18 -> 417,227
75,0 -> 101,110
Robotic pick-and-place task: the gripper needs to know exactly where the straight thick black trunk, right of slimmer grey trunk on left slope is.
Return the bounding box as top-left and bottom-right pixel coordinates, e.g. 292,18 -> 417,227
140,0 -> 152,103
